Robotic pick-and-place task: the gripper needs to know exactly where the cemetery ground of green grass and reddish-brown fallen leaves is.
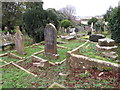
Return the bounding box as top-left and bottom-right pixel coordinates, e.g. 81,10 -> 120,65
0,30 -> 120,88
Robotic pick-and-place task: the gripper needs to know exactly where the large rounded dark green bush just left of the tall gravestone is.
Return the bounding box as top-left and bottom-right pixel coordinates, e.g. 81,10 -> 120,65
23,7 -> 47,42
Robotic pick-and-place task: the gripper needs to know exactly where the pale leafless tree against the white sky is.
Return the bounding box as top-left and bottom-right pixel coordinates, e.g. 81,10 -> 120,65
60,5 -> 76,20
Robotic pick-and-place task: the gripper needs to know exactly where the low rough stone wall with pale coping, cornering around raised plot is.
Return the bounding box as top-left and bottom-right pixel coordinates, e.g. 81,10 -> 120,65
66,42 -> 120,71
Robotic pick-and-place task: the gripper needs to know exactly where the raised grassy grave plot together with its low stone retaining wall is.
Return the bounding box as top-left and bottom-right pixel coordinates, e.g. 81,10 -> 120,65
66,41 -> 120,71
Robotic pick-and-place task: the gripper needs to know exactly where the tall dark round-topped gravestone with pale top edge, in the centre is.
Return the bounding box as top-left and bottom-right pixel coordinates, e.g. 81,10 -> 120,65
44,23 -> 59,59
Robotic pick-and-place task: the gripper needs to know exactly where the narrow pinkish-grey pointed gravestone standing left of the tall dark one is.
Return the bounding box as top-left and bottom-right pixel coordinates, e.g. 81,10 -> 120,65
15,26 -> 27,55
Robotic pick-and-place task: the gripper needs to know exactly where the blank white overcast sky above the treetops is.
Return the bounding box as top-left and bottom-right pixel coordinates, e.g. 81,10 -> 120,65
42,0 -> 120,17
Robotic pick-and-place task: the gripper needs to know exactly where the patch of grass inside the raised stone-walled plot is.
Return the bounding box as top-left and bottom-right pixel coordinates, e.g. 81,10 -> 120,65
75,42 -> 117,63
